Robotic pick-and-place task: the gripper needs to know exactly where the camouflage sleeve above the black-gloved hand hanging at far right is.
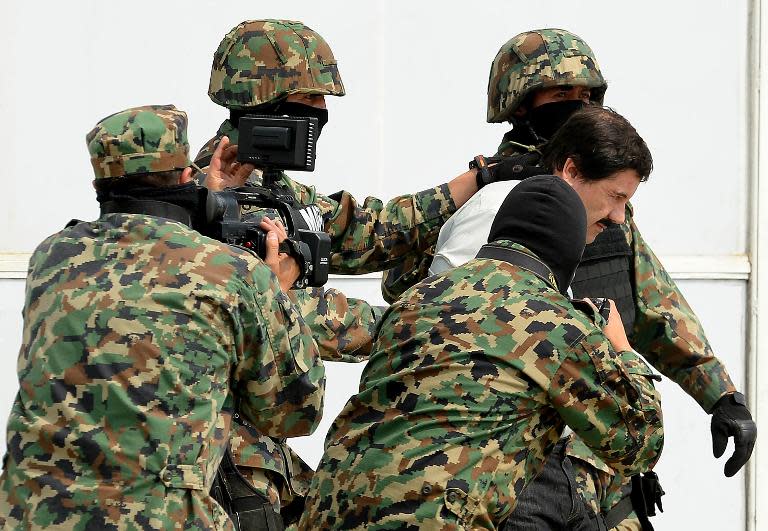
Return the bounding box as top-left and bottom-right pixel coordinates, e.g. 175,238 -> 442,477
628,214 -> 736,412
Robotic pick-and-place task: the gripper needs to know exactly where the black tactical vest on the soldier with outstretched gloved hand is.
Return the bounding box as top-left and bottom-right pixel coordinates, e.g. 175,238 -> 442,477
571,225 -> 635,339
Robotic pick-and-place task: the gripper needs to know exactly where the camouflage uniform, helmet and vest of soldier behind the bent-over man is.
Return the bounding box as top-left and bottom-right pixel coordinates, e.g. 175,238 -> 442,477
498,30 -> 736,530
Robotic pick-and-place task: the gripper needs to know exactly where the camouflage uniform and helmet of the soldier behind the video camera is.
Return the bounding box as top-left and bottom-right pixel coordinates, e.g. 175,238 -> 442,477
201,20 -> 456,520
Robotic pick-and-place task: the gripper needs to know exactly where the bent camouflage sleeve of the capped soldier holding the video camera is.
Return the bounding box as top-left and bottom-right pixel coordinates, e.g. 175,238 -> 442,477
233,264 -> 325,438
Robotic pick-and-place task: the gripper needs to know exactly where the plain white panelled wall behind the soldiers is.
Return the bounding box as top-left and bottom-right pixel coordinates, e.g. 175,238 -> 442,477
0,0 -> 749,530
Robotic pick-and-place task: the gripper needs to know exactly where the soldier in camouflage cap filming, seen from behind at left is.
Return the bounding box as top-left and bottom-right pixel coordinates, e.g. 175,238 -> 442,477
0,106 -> 325,530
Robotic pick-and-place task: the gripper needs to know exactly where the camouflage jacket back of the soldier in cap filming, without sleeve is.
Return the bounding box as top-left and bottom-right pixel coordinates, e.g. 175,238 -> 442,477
0,214 -> 268,529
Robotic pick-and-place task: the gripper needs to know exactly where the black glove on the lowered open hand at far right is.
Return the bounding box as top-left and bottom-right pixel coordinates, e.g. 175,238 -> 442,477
711,393 -> 757,477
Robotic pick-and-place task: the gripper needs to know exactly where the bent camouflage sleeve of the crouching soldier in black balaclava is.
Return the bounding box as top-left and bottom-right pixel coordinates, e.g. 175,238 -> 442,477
548,330 -> 664,476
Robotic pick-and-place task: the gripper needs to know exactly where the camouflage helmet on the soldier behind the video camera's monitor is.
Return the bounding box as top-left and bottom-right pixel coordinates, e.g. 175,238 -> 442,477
208,20 -> 344,109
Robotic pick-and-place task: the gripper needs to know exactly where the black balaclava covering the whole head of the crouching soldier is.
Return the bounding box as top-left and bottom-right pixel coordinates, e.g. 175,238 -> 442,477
488,175 -> 587,294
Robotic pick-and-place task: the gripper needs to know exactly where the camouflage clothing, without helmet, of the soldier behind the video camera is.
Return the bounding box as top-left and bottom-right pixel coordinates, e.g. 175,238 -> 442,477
196,120 -> 456,505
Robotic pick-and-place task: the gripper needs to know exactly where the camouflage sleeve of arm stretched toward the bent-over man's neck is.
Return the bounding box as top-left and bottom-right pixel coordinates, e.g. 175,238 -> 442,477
315,184 -> 456,274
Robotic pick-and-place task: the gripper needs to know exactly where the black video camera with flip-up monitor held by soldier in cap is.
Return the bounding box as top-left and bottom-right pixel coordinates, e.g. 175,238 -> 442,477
201,115 -> 331,288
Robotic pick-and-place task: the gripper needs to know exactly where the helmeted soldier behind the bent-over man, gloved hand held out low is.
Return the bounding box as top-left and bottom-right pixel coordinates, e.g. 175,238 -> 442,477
383,29 -> 756,529
